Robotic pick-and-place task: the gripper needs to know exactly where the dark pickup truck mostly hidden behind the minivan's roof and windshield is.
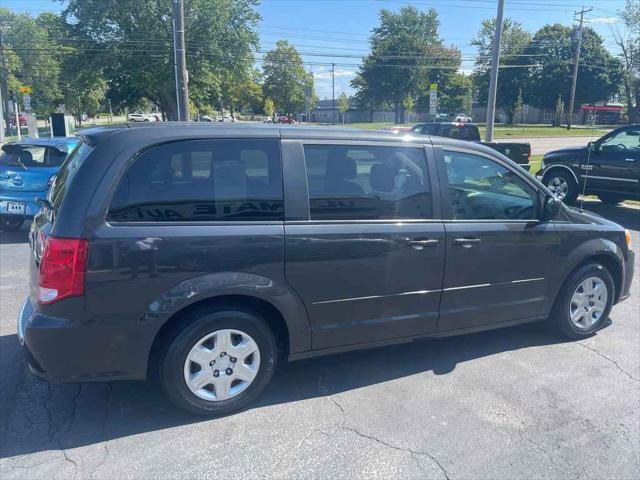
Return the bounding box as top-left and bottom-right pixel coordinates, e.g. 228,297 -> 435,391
410,122 -> 531,172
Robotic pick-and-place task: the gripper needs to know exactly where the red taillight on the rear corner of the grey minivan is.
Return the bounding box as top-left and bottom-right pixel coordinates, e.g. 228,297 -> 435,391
37,237 -> 89,303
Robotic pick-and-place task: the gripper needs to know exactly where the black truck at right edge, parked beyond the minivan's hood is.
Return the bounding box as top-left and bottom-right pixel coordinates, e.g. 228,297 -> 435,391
536,124 -> 640,204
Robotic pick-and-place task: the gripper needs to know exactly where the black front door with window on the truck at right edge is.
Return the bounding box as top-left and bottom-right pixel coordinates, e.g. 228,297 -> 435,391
583,126 -> 640,198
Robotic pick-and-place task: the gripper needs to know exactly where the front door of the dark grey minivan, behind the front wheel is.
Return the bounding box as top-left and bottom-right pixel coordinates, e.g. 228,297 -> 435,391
437,149 -> 557,331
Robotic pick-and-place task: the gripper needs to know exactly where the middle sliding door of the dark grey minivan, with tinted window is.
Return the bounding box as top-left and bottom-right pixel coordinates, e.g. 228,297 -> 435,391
285,142 -> 445,349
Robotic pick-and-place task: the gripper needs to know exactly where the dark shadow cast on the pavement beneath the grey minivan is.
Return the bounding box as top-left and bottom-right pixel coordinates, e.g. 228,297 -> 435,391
0,323 -> 596,458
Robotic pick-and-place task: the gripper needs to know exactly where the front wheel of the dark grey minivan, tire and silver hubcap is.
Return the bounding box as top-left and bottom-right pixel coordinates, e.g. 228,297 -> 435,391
550,262 -> 615,340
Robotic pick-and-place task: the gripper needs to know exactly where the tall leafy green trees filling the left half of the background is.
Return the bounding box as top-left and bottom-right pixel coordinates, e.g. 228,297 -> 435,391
0,0 -> 315,120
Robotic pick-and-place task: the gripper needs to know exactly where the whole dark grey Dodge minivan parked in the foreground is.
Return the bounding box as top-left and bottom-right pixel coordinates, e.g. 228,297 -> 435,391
18,124 -> 634,415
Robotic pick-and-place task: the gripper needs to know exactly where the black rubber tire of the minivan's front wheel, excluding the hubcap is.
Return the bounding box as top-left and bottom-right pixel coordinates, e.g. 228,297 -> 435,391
549,262 -> 615,340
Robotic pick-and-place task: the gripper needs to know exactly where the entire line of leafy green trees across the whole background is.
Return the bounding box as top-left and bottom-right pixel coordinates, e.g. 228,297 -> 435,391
0,0 -> 640,123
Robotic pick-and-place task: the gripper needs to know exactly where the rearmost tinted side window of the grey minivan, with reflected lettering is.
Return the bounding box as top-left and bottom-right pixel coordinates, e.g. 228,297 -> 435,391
107,139 -> 284,222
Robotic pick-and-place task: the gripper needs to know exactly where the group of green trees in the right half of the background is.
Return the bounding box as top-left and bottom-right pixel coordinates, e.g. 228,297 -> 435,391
352,0 -> 640,123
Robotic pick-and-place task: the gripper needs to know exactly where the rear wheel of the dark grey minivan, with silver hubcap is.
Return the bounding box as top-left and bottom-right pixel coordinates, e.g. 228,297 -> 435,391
160,307 -> 277,416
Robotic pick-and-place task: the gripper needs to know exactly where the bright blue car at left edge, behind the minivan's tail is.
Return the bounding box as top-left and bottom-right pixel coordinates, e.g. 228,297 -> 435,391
0,137 -> 78,231
